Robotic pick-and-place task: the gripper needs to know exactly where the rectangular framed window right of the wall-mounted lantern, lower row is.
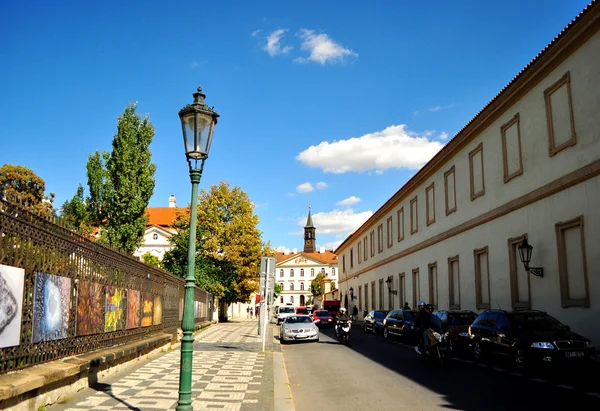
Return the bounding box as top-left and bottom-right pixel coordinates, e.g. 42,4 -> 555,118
556,216 -> 590,308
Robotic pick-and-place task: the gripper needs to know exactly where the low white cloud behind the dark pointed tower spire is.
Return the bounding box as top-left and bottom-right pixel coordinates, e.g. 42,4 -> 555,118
290,208 -> 373,238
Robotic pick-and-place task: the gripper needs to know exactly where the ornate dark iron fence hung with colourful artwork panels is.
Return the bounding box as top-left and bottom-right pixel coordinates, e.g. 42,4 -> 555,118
0,200 -> 213,374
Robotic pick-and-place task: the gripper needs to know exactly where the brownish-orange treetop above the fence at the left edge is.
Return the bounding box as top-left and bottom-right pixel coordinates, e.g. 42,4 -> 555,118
0,164 -> 54,216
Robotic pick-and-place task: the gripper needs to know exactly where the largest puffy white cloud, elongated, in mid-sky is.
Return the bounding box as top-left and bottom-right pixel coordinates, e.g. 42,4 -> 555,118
296,124 -> 443,174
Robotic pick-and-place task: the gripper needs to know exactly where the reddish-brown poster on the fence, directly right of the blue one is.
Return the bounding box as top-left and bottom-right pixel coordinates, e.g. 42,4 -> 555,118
77,280 -> 104,335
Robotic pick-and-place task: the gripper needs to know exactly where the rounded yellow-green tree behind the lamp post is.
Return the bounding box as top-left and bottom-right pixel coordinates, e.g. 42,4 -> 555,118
163,182 -> 273,304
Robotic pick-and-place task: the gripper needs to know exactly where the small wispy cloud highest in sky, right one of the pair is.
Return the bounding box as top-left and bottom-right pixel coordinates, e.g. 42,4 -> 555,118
294,29 -> 358,65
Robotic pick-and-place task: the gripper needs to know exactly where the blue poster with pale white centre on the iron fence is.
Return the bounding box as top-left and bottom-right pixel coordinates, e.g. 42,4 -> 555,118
31,272 -> 71,344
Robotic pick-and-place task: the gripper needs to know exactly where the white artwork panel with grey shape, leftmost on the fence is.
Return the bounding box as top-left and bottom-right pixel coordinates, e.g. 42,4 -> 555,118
0,264 -> 25,348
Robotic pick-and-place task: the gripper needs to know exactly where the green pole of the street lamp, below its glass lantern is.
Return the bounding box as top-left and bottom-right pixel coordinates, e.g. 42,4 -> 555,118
177,165 -> 204,411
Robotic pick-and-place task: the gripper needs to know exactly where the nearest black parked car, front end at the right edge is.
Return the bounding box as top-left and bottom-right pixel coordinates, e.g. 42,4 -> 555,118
469,310 -> 594,370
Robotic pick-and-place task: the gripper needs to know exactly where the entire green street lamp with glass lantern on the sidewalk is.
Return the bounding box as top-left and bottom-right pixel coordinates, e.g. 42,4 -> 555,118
177,87 -> 219,411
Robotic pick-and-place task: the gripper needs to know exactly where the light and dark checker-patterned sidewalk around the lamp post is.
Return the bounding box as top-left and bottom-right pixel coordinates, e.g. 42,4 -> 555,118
47,320 -> 278,411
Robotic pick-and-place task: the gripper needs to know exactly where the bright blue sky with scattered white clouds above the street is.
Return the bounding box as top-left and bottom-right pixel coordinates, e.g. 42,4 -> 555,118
0,0 -> 587,253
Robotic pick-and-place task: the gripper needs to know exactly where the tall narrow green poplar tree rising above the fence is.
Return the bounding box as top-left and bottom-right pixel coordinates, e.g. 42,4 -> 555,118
86,104 -> 156,253
